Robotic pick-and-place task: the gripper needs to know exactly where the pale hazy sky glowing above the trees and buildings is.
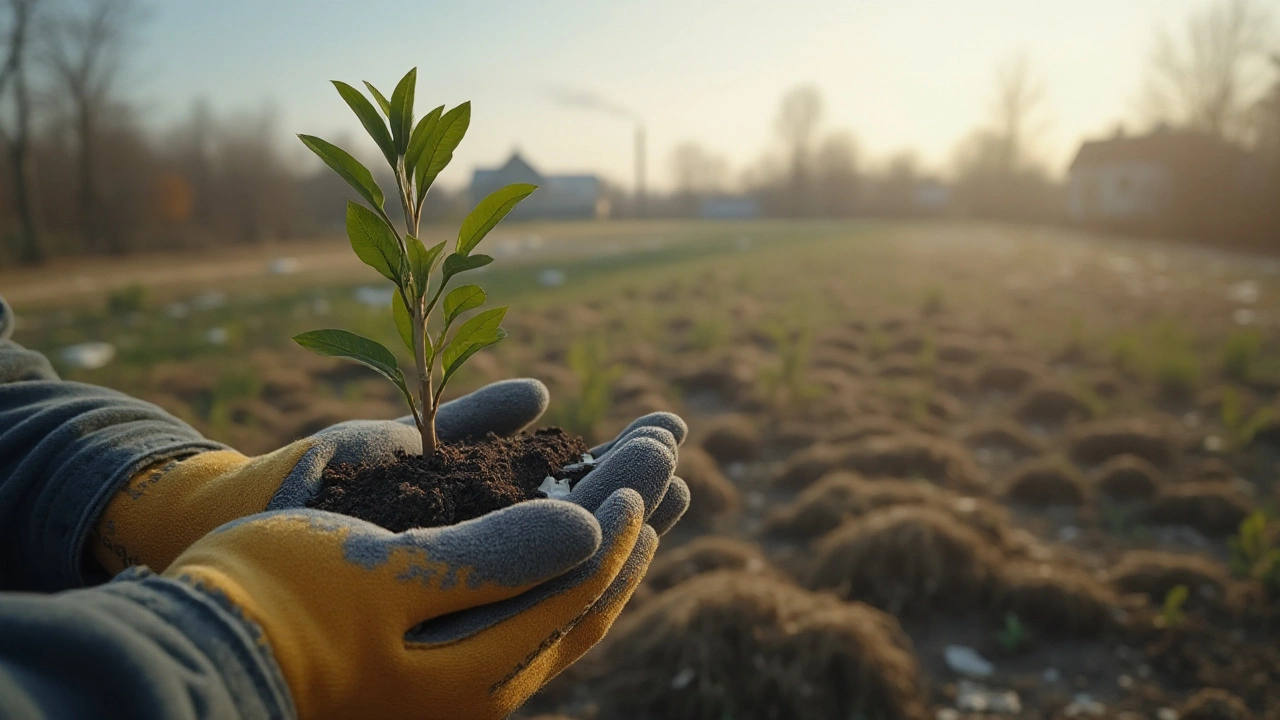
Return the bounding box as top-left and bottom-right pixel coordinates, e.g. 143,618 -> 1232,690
131,0 -> 1280,186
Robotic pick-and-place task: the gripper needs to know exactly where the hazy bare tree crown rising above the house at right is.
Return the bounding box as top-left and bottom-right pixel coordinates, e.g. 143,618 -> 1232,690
1142,0 -> 1270,138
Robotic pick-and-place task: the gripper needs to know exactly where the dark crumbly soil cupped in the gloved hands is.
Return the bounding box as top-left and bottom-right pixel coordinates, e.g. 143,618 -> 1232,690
307,428 -> 586,533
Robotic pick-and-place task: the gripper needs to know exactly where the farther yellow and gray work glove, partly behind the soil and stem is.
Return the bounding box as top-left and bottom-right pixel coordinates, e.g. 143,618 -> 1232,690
88,379 -> 560,574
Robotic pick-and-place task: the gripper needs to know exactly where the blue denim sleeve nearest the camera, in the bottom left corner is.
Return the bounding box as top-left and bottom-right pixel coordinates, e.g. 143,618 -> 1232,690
0,569 -> 296,720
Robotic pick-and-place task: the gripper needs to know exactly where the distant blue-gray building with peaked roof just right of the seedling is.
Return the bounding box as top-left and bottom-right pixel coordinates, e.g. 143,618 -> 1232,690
471,151 -> 609,220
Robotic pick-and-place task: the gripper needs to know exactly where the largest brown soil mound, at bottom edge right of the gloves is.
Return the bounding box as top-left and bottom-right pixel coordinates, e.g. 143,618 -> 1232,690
594,571 -> 931,720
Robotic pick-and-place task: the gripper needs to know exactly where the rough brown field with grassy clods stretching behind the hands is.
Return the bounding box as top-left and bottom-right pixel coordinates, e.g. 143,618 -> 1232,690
10,223 -> 1280,720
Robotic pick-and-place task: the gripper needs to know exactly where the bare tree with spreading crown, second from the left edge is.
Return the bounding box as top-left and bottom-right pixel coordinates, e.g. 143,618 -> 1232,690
46,0 -> 137,251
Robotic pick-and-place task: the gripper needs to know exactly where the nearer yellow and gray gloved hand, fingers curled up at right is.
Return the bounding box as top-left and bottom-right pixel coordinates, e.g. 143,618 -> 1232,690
165,415 -> 689,720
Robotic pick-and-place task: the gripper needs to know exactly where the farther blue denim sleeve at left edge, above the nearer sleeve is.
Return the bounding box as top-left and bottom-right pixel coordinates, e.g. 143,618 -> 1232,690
0,300 -> 225,592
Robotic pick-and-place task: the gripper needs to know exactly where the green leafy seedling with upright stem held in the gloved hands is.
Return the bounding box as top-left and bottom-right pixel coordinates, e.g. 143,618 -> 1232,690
293,68 -> 536,455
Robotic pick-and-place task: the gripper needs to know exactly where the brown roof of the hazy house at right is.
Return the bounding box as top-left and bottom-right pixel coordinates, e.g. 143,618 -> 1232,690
1071,127 -> 1243,170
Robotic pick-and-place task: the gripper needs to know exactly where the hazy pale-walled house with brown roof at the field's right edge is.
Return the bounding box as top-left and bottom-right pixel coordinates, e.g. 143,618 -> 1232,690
1068,127 -> 1248,232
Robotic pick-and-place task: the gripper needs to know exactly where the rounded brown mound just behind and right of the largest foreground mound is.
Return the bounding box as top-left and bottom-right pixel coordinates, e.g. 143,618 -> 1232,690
808,506 -> 1001,615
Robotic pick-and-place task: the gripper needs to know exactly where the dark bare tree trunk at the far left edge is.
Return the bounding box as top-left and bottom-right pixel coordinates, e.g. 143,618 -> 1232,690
0,0 -> 45,264
